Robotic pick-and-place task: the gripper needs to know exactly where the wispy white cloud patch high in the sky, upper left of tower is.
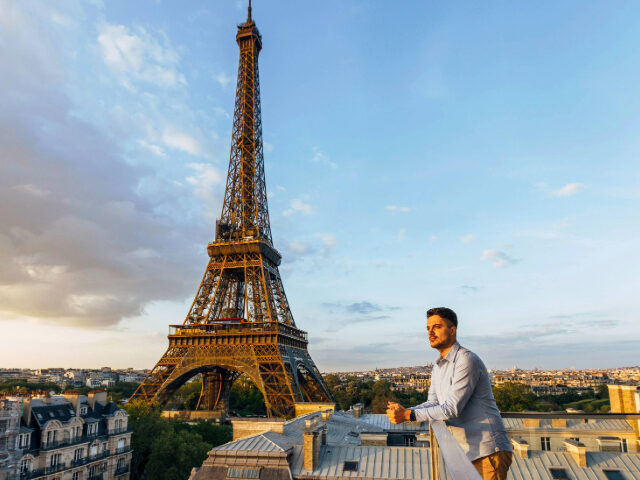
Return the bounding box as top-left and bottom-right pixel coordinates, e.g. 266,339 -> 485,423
98,24 -> 187,87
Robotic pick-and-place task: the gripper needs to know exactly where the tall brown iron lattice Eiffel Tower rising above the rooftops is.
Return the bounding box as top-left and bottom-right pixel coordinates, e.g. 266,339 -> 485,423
131,1 -> 333,417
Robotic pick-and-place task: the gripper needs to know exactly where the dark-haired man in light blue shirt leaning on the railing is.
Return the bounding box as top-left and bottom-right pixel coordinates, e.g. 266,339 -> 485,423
387,308 -> 512,480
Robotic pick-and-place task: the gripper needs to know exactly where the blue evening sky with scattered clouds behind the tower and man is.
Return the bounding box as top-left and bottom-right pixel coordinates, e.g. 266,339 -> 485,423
0,0 -> 640,372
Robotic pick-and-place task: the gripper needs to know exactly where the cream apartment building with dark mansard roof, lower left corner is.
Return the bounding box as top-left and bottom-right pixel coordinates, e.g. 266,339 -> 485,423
0,391 -> 131,480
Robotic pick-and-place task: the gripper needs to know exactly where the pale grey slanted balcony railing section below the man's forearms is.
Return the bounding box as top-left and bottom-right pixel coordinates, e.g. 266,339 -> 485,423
429,421 -> 482,480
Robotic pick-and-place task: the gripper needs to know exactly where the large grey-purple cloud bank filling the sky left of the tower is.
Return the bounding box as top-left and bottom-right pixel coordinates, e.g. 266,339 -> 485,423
0,2 -> 206,327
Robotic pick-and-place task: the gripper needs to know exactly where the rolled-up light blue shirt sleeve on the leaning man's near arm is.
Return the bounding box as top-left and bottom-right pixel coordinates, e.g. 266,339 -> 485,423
413,353 -> 481,422
